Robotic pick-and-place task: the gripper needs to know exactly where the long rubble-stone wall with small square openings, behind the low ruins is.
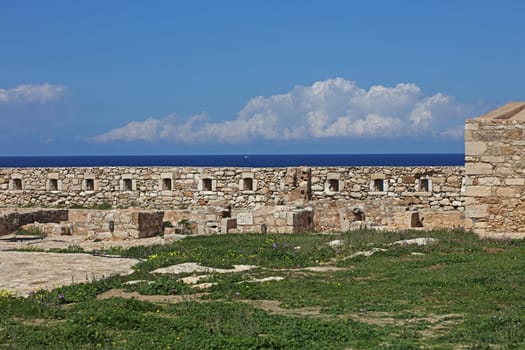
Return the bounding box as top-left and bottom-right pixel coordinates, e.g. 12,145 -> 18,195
0,167 -> 464,210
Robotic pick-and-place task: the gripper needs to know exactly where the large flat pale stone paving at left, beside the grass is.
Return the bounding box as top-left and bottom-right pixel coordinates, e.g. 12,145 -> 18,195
0,251 -> 139,296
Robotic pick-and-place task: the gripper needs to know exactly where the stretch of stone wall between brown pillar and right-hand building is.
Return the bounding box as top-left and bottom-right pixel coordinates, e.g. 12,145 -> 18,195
311,167 -> 465,231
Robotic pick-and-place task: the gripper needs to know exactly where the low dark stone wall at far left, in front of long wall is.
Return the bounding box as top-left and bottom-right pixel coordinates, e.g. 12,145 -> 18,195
0,209 -> 68,235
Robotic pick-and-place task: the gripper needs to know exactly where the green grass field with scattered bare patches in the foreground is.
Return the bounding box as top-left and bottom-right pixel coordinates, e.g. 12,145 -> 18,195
0,230 -> 525,349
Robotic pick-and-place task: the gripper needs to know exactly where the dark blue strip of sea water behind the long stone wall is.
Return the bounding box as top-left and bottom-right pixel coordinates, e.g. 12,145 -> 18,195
0,153 -> 465,168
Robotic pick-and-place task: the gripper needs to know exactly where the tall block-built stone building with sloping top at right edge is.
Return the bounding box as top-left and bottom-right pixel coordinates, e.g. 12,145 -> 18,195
465,102 -> 525,237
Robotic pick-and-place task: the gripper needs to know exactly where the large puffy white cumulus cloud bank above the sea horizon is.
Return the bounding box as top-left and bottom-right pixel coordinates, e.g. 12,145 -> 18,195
95,78 -> 465,143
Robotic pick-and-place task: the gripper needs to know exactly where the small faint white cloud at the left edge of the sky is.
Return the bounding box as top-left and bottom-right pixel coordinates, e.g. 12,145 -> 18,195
0,83 -> 65,104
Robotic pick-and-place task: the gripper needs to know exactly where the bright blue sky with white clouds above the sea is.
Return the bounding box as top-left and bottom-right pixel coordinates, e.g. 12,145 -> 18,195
0,0 -> 525,156
